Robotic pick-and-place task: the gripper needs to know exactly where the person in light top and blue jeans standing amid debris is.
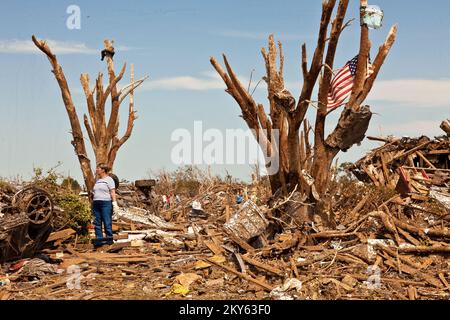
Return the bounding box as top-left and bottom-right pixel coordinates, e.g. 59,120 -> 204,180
92,164 -> 119,246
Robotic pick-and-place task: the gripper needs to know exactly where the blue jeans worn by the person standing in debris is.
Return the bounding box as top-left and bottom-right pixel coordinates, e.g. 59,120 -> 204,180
92,201 -> 113,245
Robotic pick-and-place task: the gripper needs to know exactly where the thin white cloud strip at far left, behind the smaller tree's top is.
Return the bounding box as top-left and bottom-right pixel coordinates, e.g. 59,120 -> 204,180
0,39 -> 99,54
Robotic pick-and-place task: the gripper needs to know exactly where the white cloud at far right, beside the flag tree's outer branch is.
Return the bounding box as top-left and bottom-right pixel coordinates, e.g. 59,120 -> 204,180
368,79 -> 450,107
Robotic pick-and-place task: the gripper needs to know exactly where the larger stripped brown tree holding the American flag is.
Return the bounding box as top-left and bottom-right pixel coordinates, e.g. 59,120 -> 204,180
210,0 -> 397,225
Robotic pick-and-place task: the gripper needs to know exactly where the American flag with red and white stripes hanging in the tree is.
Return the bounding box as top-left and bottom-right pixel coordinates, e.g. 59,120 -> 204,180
328,55 -> 373,111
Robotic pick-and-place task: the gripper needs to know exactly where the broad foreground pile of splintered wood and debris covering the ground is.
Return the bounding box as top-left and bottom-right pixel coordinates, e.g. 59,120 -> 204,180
0,168 -> 450,300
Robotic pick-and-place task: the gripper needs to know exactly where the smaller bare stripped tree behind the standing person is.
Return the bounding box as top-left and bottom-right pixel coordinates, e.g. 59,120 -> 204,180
32,36 -> 147,191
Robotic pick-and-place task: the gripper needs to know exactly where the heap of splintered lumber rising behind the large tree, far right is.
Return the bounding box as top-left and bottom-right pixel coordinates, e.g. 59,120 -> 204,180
351,136 -> 450,208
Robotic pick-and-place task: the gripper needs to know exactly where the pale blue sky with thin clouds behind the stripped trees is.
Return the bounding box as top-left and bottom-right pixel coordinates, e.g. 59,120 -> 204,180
0,0 -> 450,184
